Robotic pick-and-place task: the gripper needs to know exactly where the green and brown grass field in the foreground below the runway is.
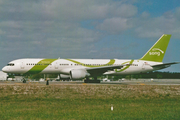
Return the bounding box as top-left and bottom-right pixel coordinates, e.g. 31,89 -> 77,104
0,84 -> 180,120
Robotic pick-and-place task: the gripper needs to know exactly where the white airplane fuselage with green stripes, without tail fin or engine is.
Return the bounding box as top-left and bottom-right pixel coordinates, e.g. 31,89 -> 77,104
2,59 -> 162,75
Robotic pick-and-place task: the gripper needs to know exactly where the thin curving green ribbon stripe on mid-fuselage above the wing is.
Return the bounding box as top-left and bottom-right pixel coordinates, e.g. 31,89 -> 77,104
66,59 -> 115,67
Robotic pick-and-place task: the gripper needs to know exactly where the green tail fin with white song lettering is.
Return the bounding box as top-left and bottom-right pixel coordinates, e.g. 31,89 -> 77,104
140,34 -> 171,62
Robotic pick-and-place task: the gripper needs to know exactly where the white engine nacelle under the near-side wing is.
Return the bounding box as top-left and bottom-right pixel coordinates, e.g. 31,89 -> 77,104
70,69 -> 89,80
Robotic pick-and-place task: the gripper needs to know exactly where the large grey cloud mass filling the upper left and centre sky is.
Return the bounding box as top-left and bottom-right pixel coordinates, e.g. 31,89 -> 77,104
0,0 -> 137,49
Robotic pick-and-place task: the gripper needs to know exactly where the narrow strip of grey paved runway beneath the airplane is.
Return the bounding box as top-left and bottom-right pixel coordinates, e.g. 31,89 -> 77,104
0,79 -> 180,85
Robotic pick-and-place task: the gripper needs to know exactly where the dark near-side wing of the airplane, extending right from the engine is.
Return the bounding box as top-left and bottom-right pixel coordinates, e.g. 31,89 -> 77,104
86,65 -> 125,76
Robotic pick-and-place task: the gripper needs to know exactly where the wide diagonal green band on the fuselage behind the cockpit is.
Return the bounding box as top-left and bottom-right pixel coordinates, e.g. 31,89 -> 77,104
26,59 -> 57,74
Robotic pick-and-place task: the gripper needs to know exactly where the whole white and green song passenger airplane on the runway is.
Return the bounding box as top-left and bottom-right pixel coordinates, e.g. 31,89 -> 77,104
2,34 -> 178,83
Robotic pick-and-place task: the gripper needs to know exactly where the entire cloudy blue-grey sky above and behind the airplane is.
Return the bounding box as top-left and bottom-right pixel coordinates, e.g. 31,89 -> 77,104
0,0 -> 180,72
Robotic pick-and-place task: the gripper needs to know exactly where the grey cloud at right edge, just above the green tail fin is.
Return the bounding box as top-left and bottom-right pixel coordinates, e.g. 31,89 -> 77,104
134,8 -> 180,38
